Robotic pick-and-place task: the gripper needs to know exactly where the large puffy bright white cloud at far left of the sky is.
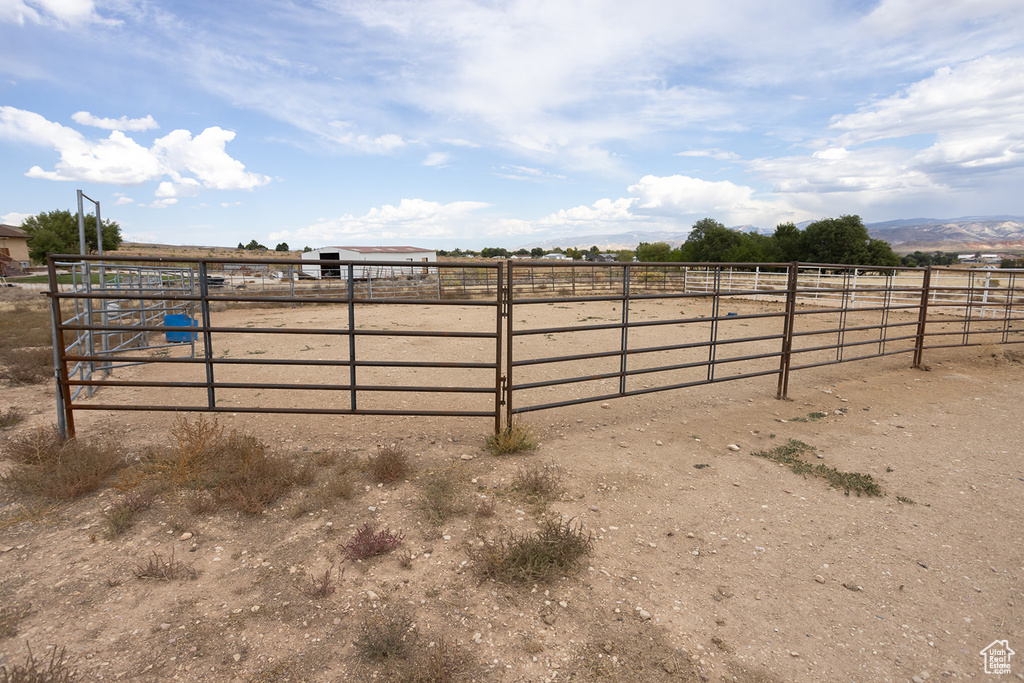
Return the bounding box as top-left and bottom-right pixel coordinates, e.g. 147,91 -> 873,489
0,106 -> 270,196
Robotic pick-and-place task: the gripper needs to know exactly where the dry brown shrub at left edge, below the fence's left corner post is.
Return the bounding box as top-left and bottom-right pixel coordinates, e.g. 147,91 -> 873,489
0,427 -> 125,500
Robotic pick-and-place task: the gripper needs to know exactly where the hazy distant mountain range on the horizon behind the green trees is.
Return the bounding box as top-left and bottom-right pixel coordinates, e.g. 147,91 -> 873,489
522,216 -> 1024,253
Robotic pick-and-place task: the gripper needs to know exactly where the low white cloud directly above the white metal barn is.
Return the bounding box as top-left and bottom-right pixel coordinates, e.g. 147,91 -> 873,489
269,199 -> 490,245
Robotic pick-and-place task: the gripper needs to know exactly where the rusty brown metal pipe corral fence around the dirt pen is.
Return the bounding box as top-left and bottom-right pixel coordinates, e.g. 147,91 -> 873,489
48,256 -> 1024,433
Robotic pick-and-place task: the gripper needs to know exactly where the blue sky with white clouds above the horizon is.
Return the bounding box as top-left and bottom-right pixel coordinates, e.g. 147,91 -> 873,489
0,0 -> 1024,249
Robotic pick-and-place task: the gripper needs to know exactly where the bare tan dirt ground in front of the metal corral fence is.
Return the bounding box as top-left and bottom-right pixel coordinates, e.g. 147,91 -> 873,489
0,294 -> 1024,682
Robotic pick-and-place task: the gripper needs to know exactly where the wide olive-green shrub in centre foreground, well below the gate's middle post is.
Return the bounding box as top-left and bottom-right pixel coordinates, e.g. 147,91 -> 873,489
469,519 -> 594,584
